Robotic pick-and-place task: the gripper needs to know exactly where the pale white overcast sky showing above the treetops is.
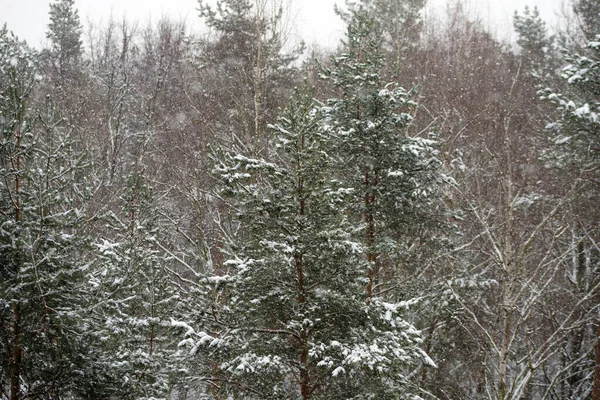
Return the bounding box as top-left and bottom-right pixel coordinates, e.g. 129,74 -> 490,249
0,0 -> 563,48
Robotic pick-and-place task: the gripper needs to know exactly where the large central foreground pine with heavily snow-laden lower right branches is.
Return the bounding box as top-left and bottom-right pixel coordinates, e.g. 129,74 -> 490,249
190,86 -> 432,399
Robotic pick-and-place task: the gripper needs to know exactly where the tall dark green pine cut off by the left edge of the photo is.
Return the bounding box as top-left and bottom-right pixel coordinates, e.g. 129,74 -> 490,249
0,28 -> 102,400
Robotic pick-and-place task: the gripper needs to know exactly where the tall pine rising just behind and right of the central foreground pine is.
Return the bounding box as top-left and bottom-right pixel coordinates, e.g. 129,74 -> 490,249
323,4 -> 443,304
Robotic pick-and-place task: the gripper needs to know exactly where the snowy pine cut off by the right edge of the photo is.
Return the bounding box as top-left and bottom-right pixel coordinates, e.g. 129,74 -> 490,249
540,0 -> 600,400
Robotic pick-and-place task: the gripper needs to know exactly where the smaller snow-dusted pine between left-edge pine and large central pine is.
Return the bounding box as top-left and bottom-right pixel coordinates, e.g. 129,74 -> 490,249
90,172 -> 179,400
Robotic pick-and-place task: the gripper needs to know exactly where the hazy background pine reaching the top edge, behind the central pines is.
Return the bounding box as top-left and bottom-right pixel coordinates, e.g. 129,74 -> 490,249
199,0 -> 303,155
